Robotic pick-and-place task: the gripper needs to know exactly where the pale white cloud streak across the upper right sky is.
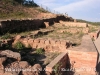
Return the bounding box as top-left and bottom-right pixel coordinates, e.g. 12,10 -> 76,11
55,0 -> 100,12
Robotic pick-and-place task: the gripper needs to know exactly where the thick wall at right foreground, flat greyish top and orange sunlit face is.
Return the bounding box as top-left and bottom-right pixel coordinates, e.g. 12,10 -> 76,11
67,35 -> 98,75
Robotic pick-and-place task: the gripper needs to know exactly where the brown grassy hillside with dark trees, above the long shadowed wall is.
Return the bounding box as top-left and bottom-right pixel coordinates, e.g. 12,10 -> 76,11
0,0 -> 48,19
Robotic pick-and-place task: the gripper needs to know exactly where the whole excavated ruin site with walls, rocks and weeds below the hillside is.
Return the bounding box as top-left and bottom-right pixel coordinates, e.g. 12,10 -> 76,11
0,15 -> 100,75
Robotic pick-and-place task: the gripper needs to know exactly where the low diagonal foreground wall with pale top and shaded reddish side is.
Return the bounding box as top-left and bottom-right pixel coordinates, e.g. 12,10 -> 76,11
46,52 -> 70,75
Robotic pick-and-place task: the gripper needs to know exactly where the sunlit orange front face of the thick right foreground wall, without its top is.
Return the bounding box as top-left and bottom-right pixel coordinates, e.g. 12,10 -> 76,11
68,49 -> 98,75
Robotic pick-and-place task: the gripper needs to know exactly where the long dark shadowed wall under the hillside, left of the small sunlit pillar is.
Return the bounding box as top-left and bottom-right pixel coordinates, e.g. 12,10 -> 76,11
0,20 -> 43,33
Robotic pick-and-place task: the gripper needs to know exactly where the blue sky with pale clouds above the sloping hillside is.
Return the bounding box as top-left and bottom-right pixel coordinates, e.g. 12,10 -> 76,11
34,0 -> 100,22
